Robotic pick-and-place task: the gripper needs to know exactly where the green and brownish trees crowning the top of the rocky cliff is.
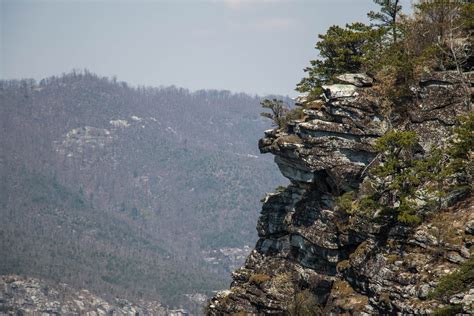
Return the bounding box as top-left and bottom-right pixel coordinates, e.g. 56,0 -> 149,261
296,0 -> 474,107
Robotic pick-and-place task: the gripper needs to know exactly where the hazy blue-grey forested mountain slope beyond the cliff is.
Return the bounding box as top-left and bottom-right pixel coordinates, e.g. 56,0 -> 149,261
0,72 -> 286,312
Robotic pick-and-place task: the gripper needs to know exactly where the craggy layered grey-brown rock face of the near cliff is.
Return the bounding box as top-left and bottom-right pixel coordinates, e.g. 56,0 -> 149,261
208,72 -> 474,315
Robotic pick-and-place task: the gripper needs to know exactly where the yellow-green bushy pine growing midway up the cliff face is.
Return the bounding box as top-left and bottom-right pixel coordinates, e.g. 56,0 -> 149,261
338,131 -> 433,224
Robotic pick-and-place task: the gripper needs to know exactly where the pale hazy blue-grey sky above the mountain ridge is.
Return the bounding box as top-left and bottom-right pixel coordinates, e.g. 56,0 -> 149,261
0,0 -> 410,96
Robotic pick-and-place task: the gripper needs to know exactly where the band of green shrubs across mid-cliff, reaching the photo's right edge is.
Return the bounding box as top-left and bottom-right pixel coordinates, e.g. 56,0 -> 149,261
336,113 -> 474,224
